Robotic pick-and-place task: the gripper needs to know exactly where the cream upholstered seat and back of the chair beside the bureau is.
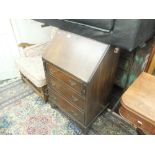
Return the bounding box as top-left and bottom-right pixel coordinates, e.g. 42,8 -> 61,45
16,42 -> 50,87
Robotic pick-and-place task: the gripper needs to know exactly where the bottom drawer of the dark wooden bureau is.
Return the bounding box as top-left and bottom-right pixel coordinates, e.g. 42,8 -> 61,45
49,90 -> 84,123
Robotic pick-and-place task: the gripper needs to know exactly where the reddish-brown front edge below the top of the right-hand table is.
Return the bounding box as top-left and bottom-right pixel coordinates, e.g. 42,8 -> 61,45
119,106 -> 155,134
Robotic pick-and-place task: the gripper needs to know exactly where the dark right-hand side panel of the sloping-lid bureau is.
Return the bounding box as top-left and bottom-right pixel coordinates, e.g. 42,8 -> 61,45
85,47 -> 120,126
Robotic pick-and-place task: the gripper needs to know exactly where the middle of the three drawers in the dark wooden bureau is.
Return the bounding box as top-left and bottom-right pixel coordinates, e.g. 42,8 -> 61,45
47,76 -> 85,109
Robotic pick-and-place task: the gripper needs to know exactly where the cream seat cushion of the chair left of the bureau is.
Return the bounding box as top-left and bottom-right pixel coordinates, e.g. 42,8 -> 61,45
16,56 -> 46,87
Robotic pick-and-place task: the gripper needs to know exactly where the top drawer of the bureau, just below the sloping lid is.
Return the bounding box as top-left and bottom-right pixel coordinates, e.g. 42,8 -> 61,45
46,63 -> 86,95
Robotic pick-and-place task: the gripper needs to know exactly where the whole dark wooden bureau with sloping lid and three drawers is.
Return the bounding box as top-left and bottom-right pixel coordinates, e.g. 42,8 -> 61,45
43,30 -> 119,131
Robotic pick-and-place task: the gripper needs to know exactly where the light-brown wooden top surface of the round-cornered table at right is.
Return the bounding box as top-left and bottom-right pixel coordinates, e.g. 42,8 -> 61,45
122,72 -> 155,123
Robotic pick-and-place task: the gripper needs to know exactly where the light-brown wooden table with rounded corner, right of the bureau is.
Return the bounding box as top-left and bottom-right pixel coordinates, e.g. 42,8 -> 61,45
119,72 -> 155,134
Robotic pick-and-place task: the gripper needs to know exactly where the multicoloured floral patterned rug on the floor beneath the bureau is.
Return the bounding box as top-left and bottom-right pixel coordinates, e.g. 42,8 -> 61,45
0,79 -> 136,135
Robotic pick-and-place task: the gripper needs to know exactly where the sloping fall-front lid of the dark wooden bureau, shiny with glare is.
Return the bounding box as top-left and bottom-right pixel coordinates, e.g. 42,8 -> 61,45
43,30 -> 109,82
